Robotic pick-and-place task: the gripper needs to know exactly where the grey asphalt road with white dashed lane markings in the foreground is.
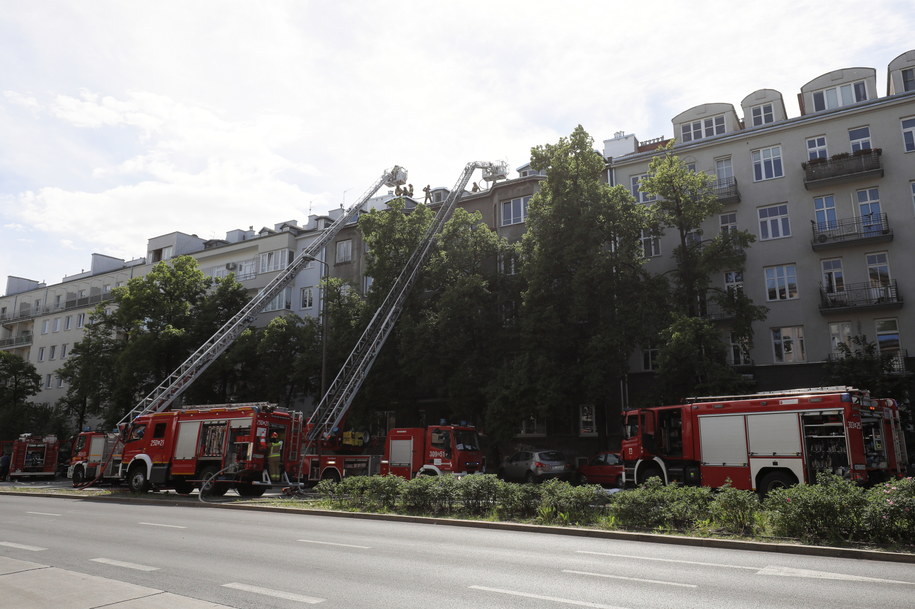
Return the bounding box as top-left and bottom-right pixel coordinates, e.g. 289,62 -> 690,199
0,495 -> 915,609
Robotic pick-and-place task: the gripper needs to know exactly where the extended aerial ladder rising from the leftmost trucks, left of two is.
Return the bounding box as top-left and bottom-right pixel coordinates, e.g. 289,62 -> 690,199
118,165 -> 407,426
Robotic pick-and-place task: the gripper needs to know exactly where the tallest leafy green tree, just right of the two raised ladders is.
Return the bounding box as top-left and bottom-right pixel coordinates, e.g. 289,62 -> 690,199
516,126 -> 660,442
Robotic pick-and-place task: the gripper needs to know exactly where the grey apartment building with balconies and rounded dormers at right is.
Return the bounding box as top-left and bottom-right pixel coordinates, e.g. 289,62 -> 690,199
604,51 -> 915,390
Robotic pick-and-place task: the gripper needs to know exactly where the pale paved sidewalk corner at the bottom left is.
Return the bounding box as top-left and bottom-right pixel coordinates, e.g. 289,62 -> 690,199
0,556 -> 232,609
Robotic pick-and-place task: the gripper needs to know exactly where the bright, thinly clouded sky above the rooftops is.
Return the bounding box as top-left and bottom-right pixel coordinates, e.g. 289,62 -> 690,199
0,0 -> 915,293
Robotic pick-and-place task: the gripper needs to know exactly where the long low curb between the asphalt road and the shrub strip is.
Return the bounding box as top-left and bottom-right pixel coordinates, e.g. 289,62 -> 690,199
7,491 -> 915,564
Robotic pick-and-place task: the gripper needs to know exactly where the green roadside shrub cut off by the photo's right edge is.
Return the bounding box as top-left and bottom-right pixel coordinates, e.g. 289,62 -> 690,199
864,478 -> 915,545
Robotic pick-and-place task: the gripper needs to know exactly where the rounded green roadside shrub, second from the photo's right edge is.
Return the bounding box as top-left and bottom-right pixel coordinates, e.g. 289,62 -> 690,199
764,472 -> 866,541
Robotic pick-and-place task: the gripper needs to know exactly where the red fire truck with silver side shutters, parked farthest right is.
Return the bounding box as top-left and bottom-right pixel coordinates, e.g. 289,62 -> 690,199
622,387 -> 907,493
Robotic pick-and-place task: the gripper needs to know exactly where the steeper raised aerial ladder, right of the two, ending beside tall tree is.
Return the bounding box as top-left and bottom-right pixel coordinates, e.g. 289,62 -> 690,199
305,161 -> 508,446
